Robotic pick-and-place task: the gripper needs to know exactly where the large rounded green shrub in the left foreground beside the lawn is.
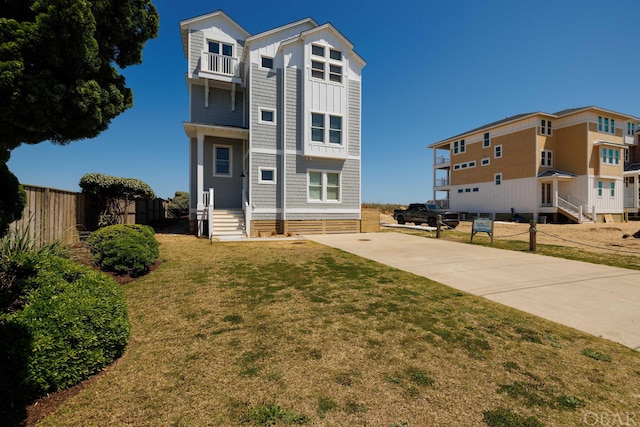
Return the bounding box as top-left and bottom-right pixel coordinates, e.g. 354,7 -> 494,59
0,254 -> 130,400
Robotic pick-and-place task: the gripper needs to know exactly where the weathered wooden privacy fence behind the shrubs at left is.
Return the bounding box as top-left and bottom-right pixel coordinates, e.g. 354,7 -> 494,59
11,185 -> 166,245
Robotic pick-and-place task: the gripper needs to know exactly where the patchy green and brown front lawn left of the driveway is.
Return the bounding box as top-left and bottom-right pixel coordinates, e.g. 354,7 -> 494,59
37,235 -> 640,427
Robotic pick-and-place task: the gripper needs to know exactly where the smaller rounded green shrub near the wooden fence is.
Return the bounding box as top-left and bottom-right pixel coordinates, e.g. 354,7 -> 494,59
87,224 -> 160,277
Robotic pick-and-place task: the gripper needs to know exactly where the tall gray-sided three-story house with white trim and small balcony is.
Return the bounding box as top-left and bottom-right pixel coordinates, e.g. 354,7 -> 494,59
180,11 -> 365,236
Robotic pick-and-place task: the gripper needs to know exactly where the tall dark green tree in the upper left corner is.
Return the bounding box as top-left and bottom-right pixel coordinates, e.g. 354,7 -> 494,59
0,0 -> 159,234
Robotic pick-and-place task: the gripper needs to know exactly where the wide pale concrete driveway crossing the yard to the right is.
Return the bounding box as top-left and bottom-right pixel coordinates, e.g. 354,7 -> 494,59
304,233 -> 640,350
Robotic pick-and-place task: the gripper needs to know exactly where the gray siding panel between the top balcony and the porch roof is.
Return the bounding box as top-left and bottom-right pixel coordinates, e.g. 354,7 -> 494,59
191,85 -> 244,127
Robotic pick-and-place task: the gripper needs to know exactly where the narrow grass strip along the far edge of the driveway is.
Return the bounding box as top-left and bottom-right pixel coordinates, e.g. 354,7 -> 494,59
383,228 -> 640,270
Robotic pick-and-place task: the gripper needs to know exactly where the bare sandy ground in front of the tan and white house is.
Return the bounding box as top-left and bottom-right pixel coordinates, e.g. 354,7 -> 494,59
380,214 -> 640,256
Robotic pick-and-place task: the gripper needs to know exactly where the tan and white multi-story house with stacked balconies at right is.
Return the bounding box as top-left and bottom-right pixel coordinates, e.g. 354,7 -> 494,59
428,107 -> 640,222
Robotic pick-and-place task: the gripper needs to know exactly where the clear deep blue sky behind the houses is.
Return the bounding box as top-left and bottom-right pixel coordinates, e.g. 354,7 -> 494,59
9,0 -> 640,204
